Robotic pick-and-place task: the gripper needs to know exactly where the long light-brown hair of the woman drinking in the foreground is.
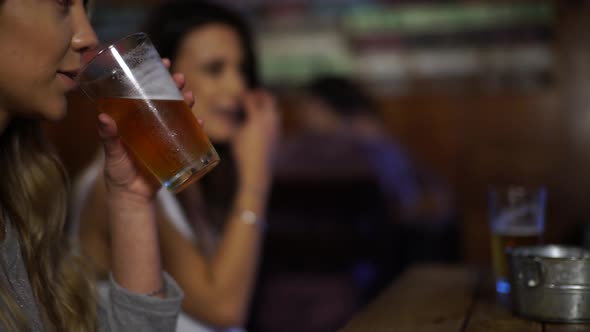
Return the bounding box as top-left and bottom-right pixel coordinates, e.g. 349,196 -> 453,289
0,119 -> 96,331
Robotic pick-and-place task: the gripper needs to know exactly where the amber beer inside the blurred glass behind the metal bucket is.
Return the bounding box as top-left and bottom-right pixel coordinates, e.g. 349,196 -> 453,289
492,227 -> 543,280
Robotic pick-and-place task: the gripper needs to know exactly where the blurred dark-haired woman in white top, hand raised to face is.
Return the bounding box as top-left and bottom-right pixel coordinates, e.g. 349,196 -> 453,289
74,1 -> 279,331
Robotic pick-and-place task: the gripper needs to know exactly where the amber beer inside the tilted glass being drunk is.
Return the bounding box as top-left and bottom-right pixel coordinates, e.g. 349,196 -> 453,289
98,98 -> 219,192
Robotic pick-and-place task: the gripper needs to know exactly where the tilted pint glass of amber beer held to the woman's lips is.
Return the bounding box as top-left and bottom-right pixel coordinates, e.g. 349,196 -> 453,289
77,33 -> 219,192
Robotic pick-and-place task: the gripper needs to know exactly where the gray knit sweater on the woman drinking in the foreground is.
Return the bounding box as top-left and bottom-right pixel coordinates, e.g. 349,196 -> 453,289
0,219 -> 183,332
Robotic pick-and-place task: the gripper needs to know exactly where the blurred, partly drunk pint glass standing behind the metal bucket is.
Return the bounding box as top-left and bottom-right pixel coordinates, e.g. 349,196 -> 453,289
489,186 -> 547,294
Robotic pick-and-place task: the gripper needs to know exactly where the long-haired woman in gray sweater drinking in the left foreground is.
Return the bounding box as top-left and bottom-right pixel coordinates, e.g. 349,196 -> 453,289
0,0 -> 208,331
